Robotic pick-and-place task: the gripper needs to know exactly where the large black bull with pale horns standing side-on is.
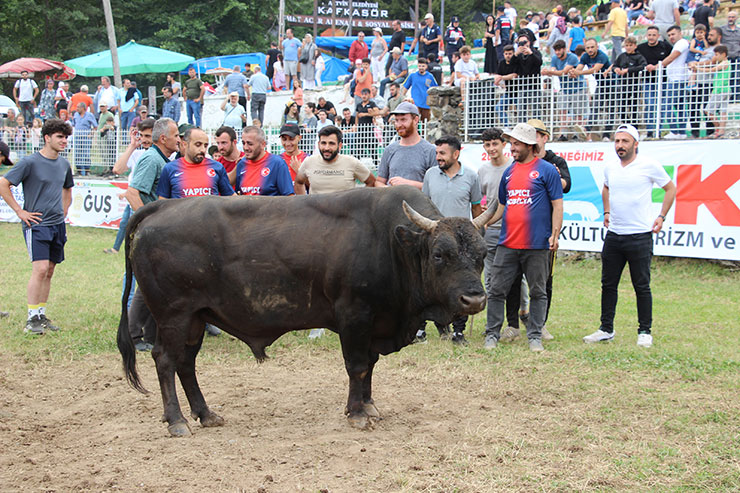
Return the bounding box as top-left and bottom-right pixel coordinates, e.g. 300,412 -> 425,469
117,187 -> 495,436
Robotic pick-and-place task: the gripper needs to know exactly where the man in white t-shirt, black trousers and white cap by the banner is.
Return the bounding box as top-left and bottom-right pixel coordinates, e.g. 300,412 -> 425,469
583,125 -> 676,347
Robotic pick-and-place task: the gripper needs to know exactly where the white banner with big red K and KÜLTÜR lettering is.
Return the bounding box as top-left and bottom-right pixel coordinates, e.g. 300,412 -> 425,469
460,140 -> 740,260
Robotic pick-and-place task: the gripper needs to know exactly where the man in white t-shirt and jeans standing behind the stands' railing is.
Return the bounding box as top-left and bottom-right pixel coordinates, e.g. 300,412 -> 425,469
663,26 -> 689,139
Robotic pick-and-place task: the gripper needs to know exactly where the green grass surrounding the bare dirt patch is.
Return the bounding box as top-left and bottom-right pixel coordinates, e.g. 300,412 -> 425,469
0,223 -> 740,491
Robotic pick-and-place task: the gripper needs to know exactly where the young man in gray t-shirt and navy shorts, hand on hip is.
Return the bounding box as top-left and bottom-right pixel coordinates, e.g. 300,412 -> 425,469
0,118 -> 74,335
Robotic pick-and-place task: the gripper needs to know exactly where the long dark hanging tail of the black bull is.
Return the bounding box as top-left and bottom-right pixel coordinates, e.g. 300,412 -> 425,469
116,200 -> 163,394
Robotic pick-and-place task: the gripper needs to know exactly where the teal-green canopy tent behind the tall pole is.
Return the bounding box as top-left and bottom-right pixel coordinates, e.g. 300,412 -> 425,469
64,40 -> 195,77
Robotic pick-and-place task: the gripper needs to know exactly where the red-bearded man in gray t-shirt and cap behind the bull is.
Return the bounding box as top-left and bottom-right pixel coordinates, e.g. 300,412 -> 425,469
375,101 -> 437,190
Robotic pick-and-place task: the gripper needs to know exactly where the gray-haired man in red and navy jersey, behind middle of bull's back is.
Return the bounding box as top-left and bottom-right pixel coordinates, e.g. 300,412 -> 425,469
233,126 -> 295,195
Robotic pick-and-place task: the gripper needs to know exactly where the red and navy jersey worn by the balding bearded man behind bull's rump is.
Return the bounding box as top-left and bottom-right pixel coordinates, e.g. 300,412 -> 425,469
157,157 -> 234,199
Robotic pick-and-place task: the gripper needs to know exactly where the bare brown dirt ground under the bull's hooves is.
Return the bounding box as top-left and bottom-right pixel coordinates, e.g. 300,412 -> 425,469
0,343 -> 736,493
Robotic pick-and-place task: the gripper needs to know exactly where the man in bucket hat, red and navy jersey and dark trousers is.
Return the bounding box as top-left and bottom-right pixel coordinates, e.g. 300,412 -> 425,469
485,123 -> 563,351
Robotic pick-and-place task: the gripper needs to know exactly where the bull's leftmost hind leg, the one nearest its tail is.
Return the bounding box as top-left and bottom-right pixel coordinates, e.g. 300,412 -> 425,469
152,316 -> 197,437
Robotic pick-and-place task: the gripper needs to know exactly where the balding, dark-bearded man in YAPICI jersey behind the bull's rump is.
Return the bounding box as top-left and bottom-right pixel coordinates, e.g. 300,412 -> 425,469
157,128 -> 234,199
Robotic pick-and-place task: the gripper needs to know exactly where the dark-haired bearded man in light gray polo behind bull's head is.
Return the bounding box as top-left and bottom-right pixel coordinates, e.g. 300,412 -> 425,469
421,136 -> 483,346
